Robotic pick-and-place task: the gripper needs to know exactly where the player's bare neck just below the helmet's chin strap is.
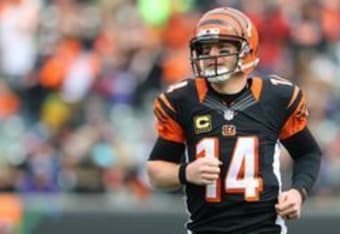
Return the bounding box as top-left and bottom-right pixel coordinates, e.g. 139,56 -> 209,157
210,73 -> 247,94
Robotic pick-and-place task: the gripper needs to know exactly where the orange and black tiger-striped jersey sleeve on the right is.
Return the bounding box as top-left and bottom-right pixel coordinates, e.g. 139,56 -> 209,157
279,86 -> 308,140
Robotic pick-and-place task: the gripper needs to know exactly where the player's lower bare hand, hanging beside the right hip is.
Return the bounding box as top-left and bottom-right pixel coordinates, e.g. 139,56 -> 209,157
275,189 -> 302,219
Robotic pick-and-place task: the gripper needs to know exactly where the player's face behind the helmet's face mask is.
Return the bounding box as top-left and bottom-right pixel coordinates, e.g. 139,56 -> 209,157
201,42 -> 238,76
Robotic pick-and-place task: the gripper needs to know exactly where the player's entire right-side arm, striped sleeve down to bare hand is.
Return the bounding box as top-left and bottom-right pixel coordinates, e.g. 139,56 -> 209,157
275,87 -> 321,219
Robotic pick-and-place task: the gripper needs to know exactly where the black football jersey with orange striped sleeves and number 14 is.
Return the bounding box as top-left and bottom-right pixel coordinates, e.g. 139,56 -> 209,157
154,76 -> 307,234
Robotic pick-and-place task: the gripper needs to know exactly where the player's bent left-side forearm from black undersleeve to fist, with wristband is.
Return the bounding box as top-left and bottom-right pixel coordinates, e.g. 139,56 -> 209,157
147,138 -> 221,189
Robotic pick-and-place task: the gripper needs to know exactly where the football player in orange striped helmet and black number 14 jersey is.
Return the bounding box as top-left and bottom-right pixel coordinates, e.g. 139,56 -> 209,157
147,8 -> 321,234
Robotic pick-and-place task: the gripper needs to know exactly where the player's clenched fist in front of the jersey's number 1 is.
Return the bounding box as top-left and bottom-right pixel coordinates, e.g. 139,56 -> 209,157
186,158 -> 222,185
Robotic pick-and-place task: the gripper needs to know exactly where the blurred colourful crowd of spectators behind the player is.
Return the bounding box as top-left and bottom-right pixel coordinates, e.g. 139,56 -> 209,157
0,0 -> 340,198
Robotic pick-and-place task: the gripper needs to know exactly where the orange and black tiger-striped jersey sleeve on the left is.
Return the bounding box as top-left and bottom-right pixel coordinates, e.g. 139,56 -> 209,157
154,93 -> 185,143
